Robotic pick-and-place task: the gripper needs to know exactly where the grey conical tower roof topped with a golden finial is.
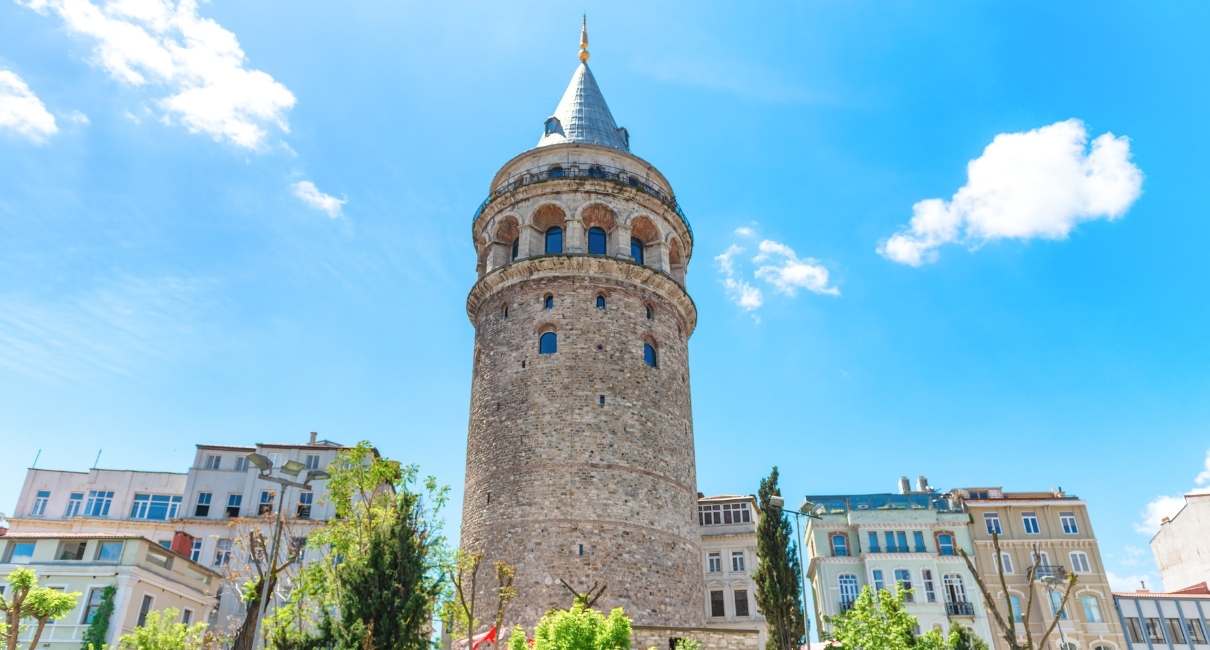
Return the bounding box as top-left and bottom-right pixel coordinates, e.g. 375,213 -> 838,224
537,19 -> 630,151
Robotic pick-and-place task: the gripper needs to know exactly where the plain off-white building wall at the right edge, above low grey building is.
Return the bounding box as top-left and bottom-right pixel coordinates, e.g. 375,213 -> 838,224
1151,491 -> 1210,591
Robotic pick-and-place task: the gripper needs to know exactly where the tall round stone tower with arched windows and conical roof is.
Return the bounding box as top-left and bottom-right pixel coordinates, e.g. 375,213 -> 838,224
461,18 -> 705,628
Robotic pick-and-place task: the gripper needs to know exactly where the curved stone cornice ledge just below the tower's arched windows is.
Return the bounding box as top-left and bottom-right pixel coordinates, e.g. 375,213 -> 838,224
466,254 -> 697,339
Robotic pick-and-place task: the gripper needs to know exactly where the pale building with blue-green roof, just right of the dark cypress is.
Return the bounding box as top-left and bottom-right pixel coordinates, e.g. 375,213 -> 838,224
803,477 -> 992,643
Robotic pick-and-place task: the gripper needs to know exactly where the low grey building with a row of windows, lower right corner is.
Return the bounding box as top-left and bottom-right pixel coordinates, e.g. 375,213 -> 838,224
1113,582 -> 1210,650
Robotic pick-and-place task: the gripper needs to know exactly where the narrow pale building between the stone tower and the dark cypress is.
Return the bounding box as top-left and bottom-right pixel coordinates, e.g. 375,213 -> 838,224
697,495 -> 768,648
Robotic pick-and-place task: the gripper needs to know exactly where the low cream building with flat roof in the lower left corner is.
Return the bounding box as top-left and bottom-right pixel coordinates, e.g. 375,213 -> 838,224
0,533 -> 223,650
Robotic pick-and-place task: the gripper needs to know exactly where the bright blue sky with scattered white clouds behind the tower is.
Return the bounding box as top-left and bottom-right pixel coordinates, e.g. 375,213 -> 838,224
0,0 -> 1210,597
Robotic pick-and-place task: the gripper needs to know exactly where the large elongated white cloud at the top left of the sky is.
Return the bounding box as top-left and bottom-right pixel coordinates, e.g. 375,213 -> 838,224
18,0 -> 294,149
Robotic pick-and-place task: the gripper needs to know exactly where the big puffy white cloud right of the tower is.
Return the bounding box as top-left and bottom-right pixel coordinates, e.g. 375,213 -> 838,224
878,119 -> 1142,266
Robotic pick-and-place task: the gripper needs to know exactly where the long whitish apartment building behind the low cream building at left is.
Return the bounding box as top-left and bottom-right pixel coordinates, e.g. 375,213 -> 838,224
8,433 -> 342,633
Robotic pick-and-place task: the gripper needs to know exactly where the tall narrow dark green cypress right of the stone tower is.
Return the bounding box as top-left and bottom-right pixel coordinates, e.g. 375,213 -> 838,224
753,466 -> 805,650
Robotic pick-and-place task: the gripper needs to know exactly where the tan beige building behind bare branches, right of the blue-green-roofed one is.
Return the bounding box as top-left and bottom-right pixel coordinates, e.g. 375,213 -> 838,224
951,487 -> 1127,650
